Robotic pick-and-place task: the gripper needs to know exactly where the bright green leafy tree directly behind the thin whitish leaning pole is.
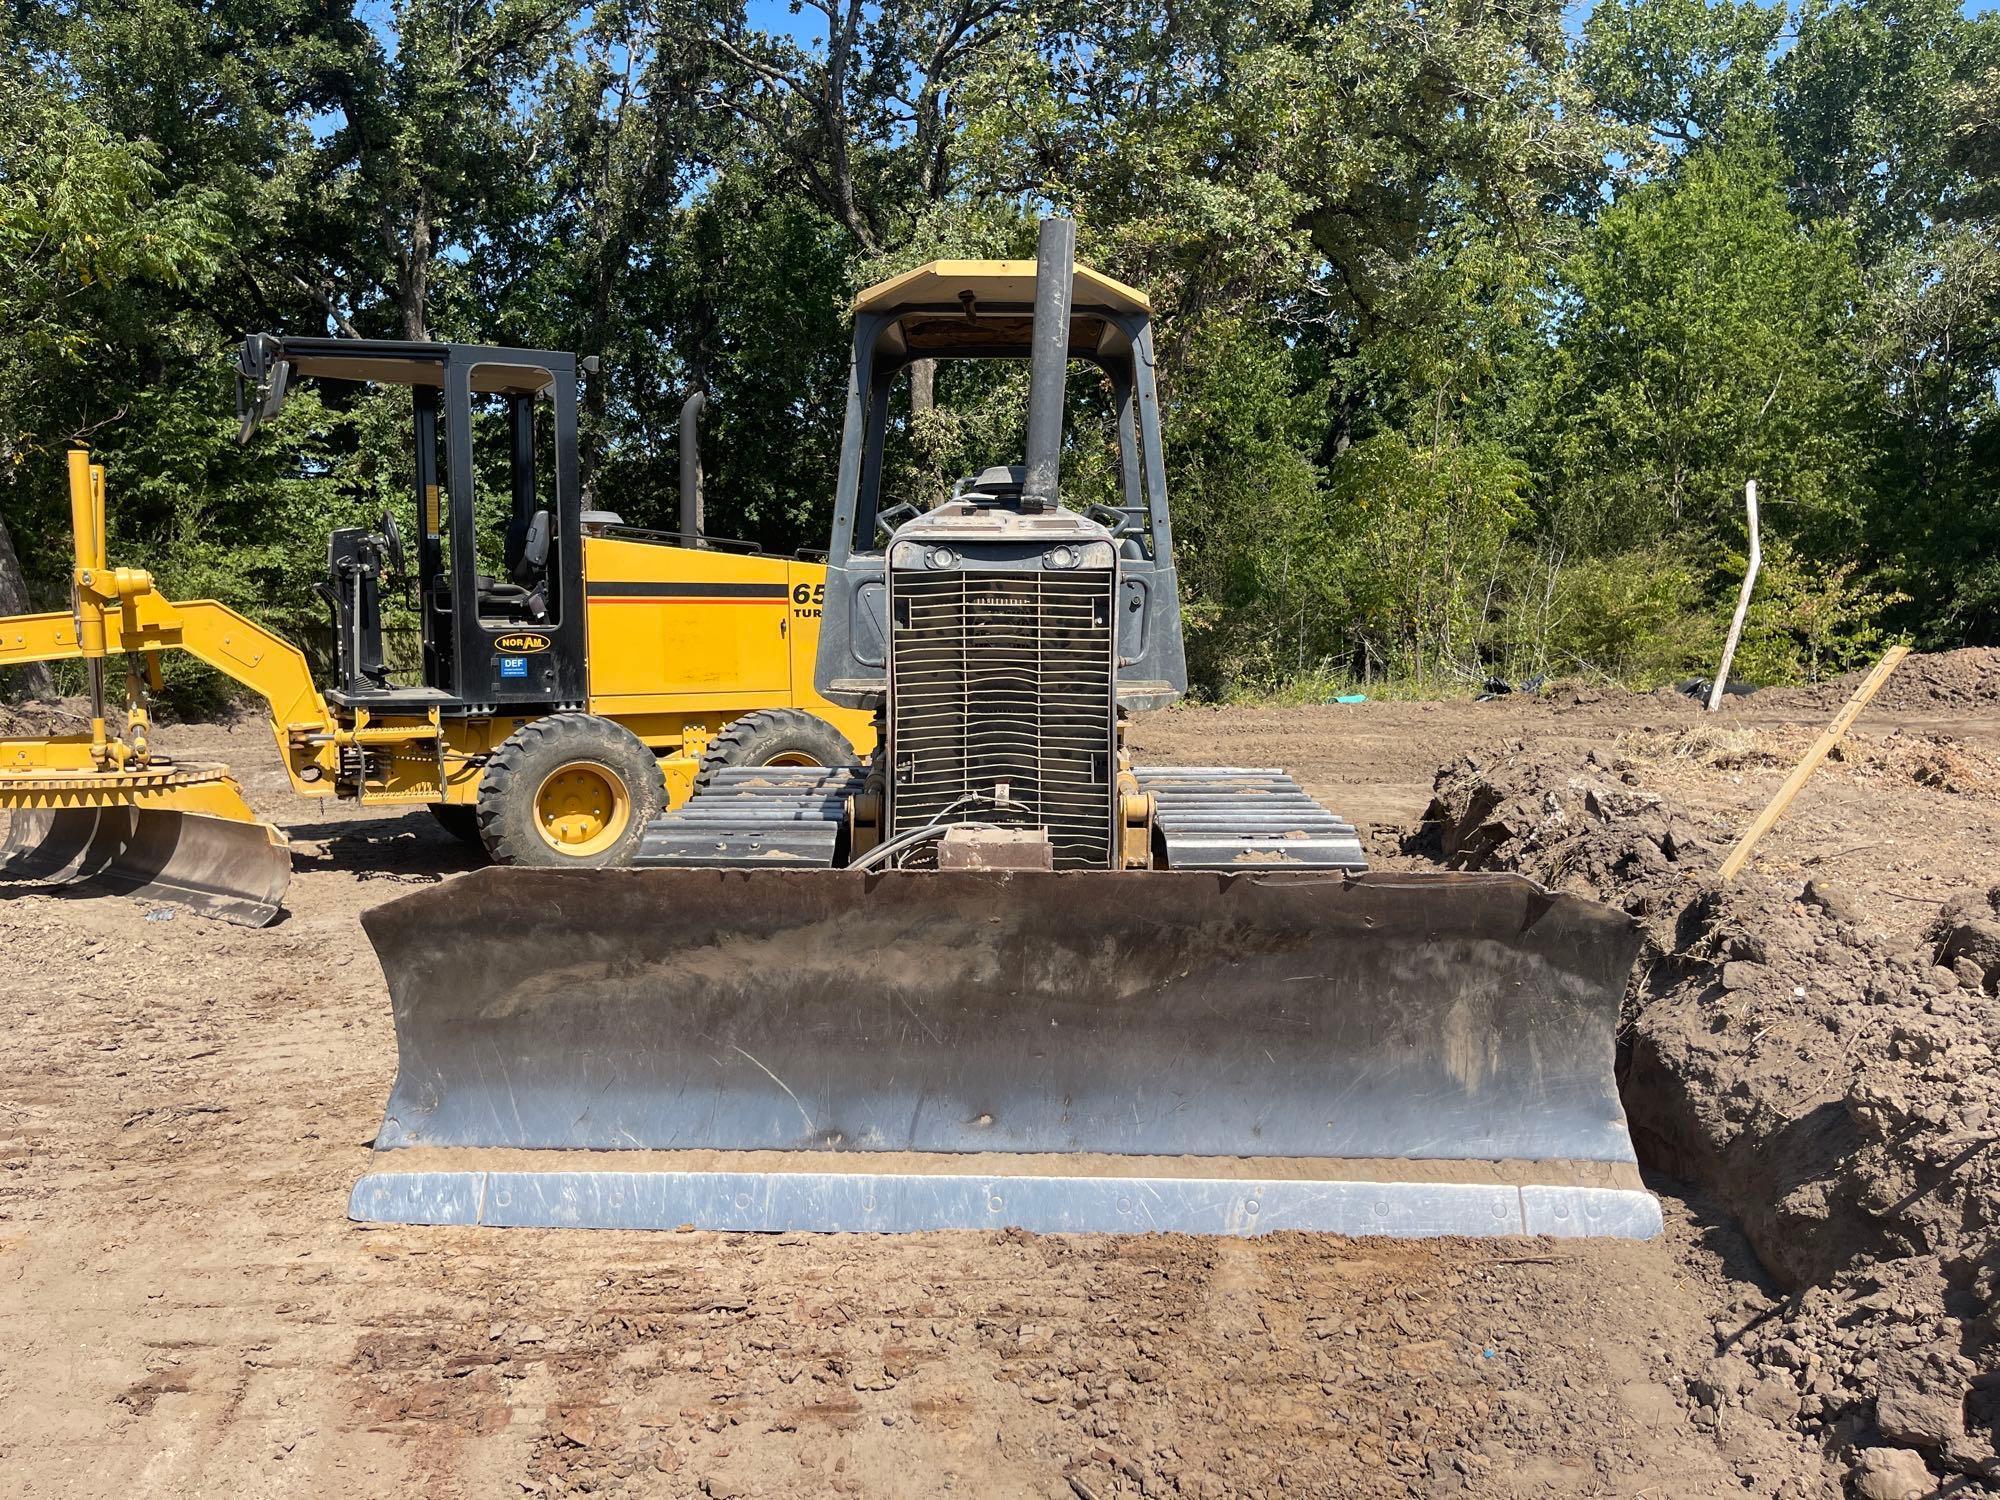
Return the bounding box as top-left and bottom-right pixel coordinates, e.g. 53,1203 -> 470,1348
1544,128 -> 1872,556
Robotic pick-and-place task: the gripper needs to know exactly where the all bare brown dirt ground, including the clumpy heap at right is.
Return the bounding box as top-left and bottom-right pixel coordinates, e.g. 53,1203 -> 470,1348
0,658 -> 2000,1500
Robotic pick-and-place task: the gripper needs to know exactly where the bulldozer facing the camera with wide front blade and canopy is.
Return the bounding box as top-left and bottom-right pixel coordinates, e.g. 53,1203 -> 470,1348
348,220 -> 1660,1236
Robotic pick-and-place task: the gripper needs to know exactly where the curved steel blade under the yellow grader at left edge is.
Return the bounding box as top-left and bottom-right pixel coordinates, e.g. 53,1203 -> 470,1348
0,806 -> 292,928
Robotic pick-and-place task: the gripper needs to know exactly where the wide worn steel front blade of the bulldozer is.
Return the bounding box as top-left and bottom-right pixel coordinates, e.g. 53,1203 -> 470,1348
348,870 -> 1660,1236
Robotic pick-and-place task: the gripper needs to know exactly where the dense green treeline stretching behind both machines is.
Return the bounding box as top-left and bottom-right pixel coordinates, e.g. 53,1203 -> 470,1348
0,0 -> 2000,712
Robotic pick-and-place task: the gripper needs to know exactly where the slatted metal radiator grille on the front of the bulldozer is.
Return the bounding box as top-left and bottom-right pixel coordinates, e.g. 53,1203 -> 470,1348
890,572 -> 1116,870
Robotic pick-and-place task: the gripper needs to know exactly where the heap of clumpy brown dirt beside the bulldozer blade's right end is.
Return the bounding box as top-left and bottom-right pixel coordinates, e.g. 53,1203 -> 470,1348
1412,744 -> 2000,1496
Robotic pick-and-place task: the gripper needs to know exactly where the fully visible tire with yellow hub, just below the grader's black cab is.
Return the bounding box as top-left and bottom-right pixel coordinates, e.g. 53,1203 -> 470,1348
478,714 -> 666,870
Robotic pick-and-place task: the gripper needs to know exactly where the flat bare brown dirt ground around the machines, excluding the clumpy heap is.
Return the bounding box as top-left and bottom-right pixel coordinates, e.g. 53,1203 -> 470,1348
0,668 -> 2000,1500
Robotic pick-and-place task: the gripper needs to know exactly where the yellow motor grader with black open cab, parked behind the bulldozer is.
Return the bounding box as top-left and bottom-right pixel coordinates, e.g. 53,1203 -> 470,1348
0,344 -> 874,926
